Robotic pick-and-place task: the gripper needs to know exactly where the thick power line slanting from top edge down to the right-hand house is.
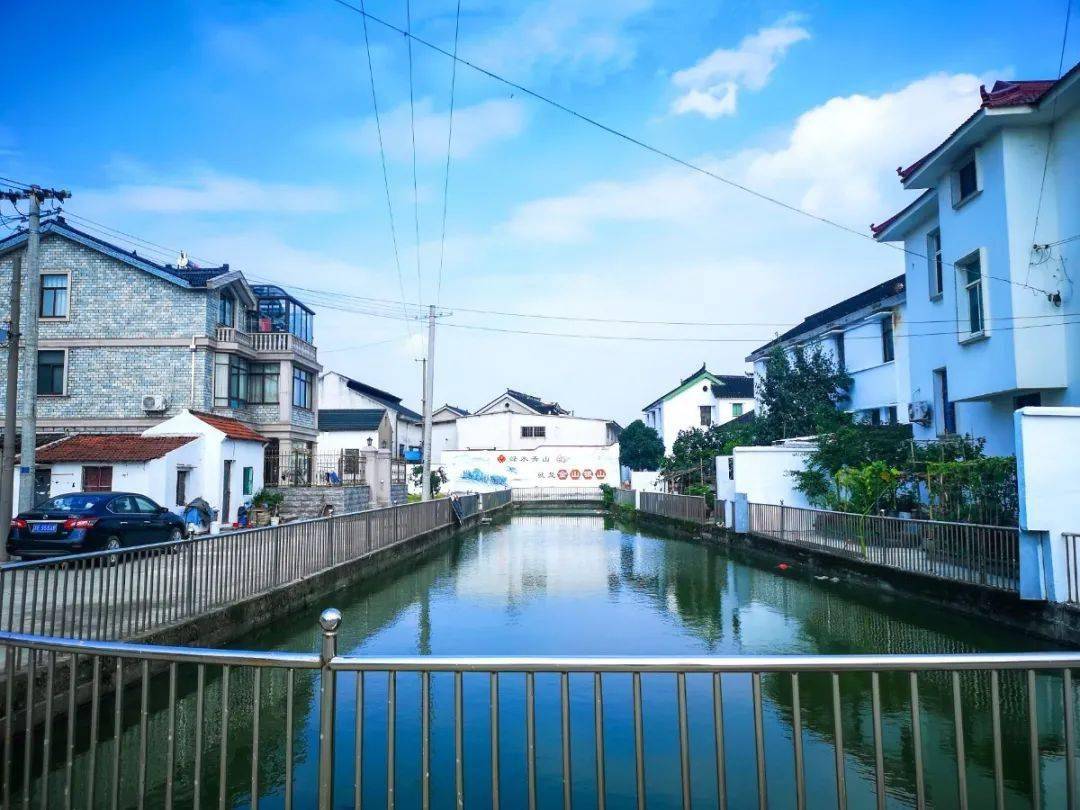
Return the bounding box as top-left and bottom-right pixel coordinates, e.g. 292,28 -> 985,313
332,0 -> 1053,295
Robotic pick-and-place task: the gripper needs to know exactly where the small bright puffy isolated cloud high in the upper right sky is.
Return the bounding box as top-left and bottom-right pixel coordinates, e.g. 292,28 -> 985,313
672,15 -> 810,119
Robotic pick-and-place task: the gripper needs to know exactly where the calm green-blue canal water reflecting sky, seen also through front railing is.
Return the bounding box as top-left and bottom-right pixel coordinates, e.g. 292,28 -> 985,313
23,514 -> 1065,808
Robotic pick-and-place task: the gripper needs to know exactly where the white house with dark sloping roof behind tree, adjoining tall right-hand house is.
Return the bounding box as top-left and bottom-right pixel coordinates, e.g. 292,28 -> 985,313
746,275 -> 908,432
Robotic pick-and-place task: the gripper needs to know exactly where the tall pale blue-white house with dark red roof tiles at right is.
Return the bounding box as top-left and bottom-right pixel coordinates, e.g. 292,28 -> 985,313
873,66 -> 1080,454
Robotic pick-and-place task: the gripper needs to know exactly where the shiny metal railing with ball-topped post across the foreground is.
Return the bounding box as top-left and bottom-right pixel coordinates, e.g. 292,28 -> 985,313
0,609 -> 1080,808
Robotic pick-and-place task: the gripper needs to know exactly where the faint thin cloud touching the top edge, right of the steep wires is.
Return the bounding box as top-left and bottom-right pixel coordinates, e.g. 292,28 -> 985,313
461,0 -> 652,77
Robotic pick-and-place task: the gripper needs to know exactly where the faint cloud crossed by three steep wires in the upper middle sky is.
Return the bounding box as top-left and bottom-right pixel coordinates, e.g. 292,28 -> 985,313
330,98 -> 525,161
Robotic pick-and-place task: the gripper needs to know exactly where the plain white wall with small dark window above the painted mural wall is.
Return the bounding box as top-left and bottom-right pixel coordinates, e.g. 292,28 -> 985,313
455,411 -> 619,453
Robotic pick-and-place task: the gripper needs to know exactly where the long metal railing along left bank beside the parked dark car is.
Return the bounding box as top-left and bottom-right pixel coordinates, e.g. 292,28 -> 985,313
0,498 -> 451,639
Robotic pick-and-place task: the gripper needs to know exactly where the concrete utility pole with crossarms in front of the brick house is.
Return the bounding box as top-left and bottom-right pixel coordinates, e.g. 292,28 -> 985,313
2,186 -> 71,509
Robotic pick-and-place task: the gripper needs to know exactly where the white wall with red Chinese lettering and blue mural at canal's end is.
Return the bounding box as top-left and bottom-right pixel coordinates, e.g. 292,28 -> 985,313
442,444 -> 619,492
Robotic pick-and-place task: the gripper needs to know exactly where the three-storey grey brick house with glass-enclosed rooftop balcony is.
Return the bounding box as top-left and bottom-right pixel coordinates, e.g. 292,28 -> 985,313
0,216 -> 322,498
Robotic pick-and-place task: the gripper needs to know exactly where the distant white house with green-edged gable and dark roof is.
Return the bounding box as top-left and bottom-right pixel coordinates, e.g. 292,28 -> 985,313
642,364 -> 754,453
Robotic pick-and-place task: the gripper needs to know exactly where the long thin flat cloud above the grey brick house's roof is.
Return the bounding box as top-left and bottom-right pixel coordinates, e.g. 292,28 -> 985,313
79,170 -> 342,216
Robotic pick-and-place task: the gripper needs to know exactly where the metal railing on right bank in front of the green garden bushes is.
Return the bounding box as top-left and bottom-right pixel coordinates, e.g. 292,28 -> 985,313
750,503 -> 1020,591
